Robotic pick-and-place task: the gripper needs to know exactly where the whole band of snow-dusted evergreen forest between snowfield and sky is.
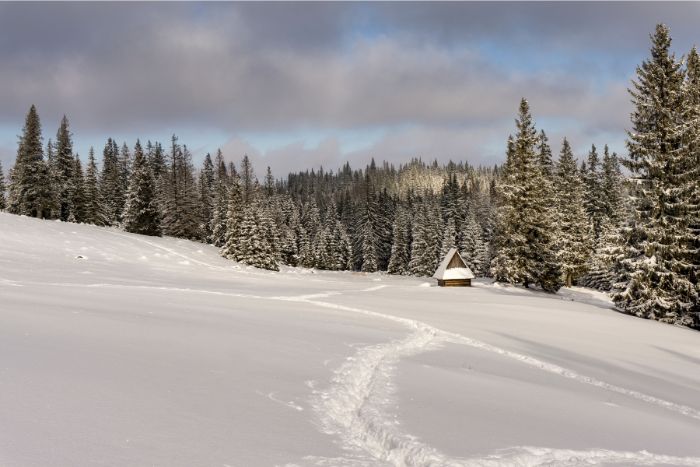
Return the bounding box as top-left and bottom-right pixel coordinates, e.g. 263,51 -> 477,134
0,25 -> 700,327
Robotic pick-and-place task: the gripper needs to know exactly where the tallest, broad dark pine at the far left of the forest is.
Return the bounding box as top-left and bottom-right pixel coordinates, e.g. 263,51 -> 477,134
8,105 -> 55,219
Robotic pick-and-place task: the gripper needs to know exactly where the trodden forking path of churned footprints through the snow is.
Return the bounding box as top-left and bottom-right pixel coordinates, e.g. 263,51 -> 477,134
286,294 -> 700,467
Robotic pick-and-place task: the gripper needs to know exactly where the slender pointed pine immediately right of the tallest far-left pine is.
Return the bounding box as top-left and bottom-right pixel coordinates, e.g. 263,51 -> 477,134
52,115 -> 76,221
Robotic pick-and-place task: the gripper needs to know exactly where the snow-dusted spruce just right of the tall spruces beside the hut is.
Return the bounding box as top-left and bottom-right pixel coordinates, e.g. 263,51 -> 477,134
556,138 -> 600,287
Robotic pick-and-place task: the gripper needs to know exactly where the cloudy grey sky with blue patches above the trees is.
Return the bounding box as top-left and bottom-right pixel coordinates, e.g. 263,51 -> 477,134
0,2 -> 700,177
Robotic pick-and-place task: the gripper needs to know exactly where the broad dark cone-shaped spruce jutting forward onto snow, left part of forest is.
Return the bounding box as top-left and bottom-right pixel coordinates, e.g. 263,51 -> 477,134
122,140 -> 161,236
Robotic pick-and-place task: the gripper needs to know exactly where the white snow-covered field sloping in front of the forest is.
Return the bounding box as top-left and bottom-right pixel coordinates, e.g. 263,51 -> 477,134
0,213 -> 700,467
